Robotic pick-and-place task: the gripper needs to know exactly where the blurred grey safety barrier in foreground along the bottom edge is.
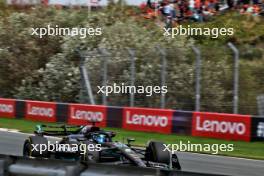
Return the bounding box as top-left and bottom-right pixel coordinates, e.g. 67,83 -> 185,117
0,155 -> 228,176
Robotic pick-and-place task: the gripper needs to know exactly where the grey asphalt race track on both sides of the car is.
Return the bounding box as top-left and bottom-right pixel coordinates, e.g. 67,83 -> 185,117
0,131 -> 264,176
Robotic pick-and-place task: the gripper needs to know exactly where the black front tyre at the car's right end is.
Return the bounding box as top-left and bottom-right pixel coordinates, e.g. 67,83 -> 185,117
145,141 -> 170,164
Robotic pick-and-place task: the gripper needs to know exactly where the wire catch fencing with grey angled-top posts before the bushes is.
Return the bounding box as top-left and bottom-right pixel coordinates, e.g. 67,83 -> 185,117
74,43 -> 262,114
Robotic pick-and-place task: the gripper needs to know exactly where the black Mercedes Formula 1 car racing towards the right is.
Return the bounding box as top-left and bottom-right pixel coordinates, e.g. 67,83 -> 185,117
23,124 -> 181,170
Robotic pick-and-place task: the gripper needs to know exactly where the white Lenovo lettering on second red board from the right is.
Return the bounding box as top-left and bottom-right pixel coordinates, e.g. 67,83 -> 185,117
126,111 -> 168,127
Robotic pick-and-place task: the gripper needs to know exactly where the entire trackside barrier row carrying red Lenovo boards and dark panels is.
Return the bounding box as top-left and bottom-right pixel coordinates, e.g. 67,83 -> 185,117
0,98 -> 264,141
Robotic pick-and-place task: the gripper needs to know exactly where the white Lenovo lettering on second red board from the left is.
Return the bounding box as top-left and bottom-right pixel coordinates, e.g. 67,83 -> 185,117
28,105 -> 54,117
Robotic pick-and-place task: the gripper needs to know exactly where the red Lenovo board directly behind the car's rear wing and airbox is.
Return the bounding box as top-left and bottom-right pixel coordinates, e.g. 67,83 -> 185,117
68,104 -> 107,127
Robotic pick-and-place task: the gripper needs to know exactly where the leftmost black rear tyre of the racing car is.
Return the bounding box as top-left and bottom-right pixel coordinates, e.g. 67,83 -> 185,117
23,136 -> 49,158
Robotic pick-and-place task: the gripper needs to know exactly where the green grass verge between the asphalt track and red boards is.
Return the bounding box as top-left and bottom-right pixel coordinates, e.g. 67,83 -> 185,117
0,118 -> 264,160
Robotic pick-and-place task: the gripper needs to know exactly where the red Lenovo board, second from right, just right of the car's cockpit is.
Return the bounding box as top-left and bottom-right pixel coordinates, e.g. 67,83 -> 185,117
123,107 -> 173,134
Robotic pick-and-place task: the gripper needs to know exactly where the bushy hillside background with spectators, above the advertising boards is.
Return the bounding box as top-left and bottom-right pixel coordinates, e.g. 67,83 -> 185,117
0,0 -> 264,115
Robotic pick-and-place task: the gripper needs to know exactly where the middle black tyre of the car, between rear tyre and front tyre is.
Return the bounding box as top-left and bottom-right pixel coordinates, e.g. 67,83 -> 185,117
81,141 -> 100,164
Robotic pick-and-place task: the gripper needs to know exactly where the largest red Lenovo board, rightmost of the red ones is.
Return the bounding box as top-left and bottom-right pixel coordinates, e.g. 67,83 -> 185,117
192,112 -> 251,141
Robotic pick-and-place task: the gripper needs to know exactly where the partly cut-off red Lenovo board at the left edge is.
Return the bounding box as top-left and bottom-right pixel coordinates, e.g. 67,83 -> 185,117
0,98 -> 16,118
